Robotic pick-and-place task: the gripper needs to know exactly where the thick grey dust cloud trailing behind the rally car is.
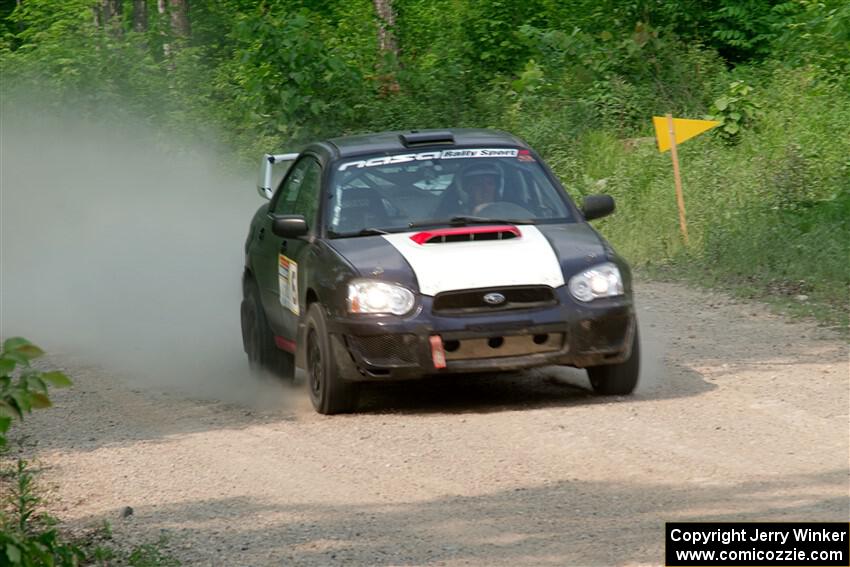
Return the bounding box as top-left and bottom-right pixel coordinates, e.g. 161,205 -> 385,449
0,105 -> 288,402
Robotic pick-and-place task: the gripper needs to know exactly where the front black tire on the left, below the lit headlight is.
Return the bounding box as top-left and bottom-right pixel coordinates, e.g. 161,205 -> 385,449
305,303 -> 359,415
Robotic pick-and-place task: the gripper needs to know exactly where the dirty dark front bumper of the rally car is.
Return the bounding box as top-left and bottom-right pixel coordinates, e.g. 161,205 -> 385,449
310,286 -> 637,381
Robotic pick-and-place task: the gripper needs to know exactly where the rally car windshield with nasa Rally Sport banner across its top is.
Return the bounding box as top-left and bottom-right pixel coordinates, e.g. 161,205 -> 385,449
326,148 -> 572,236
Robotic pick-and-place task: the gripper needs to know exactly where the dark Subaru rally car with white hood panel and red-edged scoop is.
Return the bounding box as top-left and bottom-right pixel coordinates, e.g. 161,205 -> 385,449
241,129 -> 639,414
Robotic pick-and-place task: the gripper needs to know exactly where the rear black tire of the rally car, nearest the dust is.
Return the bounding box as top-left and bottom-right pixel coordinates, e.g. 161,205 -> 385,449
240,280 -> 294,380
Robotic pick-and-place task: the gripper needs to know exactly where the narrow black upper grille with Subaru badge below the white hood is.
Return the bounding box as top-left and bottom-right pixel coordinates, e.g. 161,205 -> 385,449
434,285 -> 557,314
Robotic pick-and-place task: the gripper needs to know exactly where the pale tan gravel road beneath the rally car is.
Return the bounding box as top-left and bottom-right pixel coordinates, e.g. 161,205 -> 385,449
9,282 -> 850,566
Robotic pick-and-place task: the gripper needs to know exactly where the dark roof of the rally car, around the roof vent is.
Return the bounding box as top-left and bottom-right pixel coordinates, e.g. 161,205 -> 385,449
326,128 -> 528,157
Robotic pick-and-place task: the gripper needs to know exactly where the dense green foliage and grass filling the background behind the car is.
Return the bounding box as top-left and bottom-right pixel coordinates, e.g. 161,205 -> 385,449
0,0 -> 850,322
